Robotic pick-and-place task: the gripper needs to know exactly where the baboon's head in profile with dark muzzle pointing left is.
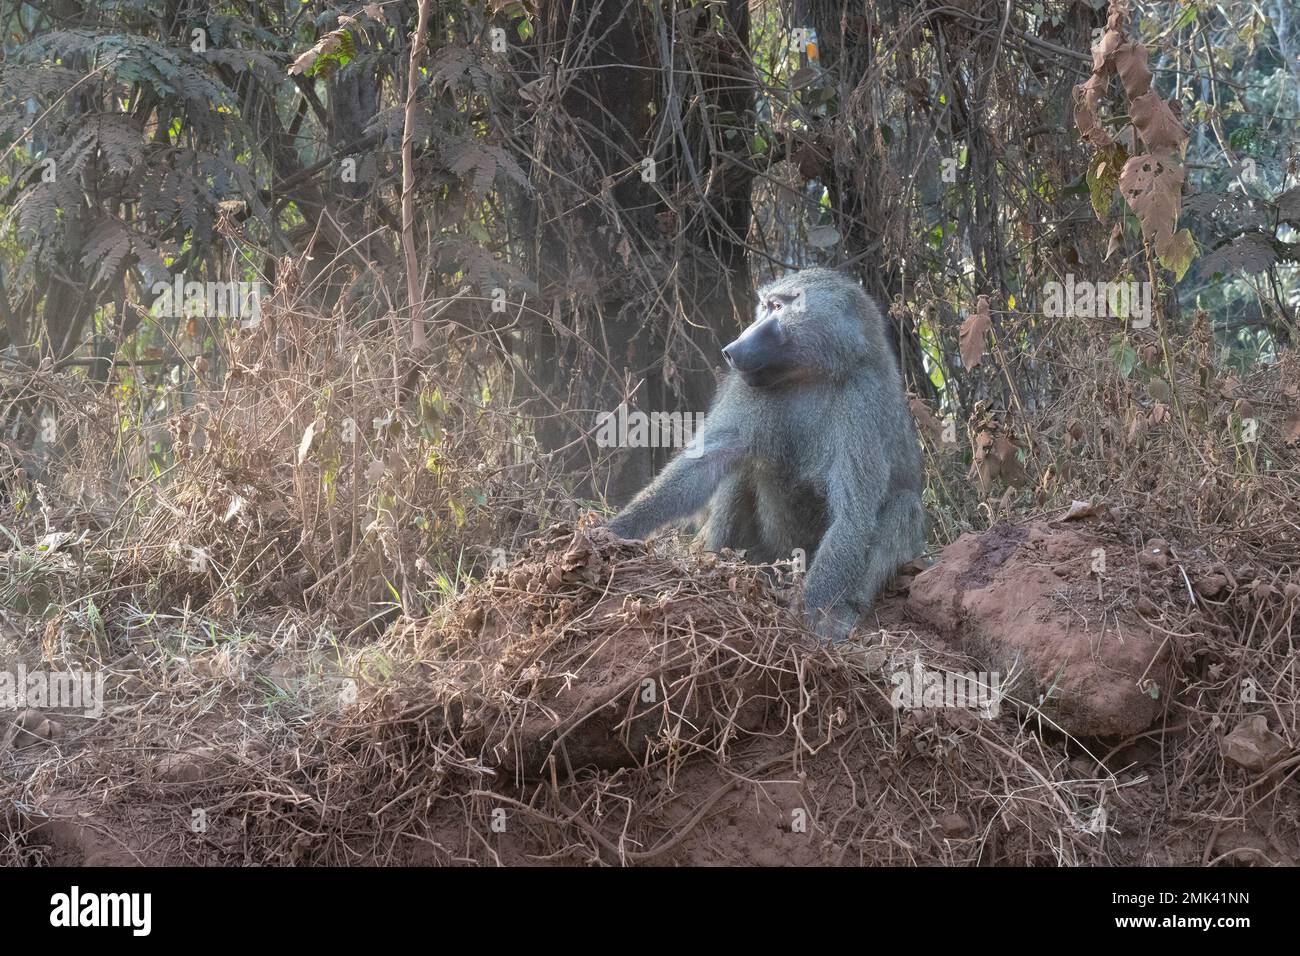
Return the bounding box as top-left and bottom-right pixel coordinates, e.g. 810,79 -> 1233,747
723,269 -> 879,388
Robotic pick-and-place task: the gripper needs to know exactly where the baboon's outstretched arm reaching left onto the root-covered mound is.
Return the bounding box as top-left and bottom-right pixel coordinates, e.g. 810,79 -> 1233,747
610,431 -> 740,538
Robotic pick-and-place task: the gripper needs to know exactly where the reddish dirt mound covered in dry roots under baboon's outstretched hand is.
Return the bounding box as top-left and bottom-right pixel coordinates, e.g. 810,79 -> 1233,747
417,527 -> 802,777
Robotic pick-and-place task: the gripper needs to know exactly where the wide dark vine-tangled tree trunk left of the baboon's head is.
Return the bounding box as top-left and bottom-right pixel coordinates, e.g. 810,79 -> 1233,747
524,0 -> 754,503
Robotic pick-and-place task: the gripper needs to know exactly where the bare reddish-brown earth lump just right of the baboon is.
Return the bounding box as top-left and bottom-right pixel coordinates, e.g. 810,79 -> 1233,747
909,522 -> 1173,737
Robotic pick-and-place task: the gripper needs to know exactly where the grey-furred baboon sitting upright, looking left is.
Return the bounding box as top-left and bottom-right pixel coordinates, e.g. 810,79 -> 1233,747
610,269 -> 924,640
